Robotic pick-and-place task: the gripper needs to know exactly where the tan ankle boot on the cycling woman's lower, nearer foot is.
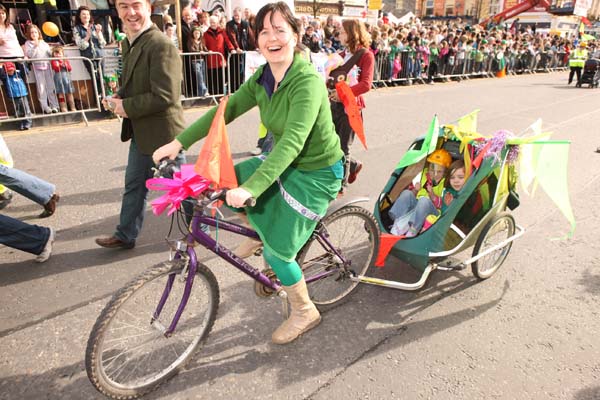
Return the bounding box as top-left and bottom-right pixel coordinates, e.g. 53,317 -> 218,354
271,278 -> 321,344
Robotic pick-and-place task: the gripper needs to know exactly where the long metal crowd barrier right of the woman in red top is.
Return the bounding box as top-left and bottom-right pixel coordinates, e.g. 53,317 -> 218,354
373,50 -> 568,87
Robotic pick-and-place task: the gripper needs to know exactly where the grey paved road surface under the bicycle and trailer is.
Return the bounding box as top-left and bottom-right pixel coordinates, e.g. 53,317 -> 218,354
0,73 -> 600,400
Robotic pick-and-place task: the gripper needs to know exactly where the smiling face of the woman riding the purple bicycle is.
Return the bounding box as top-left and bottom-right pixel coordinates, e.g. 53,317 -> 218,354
258,12 -> 297,68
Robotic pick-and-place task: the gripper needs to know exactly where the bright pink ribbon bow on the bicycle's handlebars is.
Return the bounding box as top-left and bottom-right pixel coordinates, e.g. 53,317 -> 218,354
146,164 -> 210,215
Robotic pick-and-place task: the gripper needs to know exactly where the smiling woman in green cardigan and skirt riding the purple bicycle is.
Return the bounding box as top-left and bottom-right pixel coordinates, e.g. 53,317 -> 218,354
153,2 -> 343,344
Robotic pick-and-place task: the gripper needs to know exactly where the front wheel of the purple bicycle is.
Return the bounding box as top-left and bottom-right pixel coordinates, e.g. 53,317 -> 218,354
85,261 -> 219,399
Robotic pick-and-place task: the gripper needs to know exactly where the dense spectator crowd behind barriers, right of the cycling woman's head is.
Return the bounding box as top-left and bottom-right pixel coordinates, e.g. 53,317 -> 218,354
294,16 -> 598,83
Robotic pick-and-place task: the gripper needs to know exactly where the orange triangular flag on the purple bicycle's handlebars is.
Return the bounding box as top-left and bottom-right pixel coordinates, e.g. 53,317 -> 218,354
194,97 -> 238,189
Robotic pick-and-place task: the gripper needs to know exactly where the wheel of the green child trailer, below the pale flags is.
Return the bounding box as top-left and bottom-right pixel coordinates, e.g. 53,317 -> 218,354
471,212 -> 515,280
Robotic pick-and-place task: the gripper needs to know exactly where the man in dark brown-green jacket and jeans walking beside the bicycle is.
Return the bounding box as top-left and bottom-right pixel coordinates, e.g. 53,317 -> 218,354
96,0 -> 184,249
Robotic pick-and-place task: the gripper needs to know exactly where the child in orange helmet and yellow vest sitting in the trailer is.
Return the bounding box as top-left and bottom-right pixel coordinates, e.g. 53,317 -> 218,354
389,149 -> 452,238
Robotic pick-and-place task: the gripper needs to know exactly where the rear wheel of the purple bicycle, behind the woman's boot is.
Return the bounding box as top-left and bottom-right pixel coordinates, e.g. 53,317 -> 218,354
297,206 -> 379,310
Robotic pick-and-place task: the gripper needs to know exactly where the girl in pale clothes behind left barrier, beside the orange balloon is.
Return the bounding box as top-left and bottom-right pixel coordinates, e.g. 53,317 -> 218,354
23,25 -> 58,114
